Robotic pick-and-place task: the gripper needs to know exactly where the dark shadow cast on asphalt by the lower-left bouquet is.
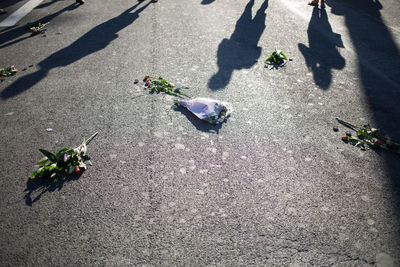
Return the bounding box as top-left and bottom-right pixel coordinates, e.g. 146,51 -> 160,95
24,174 -> 82,206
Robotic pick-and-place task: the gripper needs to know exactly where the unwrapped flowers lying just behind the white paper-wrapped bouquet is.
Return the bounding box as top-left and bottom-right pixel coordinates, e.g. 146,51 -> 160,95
143,75 -> 188,97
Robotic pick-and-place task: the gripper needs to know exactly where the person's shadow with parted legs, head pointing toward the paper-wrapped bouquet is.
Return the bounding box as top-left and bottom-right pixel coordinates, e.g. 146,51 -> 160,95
208,0 -> 268,90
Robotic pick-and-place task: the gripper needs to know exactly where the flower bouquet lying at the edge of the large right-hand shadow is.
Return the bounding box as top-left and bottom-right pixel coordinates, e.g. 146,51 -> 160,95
336,118 -> 400,154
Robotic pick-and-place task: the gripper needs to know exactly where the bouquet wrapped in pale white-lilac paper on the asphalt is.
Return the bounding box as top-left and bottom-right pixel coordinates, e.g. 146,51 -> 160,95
175,97 -> 232,125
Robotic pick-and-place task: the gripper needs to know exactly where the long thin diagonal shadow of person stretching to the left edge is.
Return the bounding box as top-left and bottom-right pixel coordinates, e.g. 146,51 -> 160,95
1,2 -> 151,99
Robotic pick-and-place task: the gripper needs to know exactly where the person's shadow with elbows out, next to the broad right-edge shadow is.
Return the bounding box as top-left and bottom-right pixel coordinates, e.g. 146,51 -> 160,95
298,7 -> 346,90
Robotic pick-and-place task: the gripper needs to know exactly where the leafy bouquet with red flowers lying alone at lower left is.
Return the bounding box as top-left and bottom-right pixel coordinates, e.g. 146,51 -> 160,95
29,133 -> 97,179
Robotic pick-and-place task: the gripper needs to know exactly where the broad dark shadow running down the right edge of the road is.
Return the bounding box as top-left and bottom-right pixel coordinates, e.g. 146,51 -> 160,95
327,0 -> 400,216
